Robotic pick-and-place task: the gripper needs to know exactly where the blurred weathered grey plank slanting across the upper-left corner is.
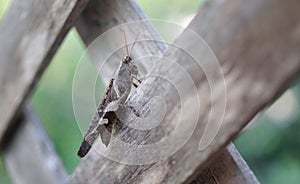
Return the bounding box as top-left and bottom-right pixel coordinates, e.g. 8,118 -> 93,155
0,0 -> 88,146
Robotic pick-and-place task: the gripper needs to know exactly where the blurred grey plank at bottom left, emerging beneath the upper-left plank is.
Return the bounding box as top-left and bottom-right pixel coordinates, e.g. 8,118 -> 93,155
3,104 -> 67,184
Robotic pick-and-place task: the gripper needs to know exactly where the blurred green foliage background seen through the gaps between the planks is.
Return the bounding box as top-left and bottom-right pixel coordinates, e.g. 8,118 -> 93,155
0,0 -> 300,184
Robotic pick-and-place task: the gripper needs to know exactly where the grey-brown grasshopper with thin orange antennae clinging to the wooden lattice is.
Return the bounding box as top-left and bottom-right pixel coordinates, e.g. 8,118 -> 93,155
77,27 -> 141,158
